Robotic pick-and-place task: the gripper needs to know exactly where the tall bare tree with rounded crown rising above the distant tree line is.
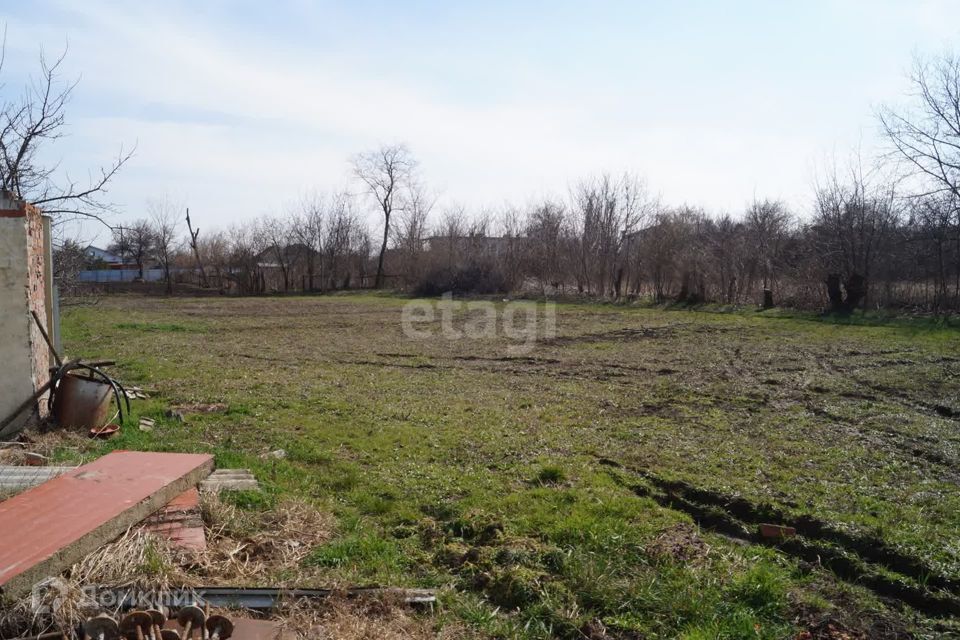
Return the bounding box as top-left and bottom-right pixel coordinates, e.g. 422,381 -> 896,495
353,144 -> 417,289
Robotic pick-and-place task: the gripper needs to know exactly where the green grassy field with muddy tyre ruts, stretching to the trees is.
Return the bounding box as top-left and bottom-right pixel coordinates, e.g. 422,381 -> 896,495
59,296 -> 960,639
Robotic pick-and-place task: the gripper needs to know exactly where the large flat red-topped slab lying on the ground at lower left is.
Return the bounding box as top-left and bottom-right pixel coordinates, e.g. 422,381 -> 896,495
0,451 -> 213,597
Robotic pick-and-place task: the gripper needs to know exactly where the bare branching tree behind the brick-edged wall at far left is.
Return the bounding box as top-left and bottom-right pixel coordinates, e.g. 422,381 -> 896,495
0,38 -> 133,221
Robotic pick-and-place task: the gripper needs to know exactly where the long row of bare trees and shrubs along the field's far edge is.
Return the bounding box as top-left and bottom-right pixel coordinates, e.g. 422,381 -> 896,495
82,148 -> 960,312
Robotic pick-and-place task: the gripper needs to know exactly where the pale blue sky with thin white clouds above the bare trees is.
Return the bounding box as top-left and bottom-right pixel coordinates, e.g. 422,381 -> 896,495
0,0 -> 960,238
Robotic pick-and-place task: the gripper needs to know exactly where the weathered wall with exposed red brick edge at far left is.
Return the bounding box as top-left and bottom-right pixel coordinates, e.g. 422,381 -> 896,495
0,194 -> 50,436
